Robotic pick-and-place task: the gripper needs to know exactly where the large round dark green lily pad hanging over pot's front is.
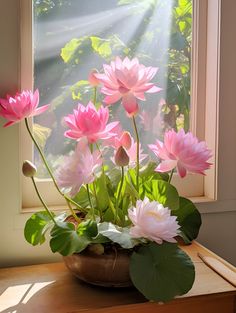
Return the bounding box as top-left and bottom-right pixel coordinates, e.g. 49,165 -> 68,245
130,242 -> 195,302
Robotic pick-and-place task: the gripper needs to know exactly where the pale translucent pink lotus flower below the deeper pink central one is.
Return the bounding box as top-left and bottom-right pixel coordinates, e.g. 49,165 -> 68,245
56,139 -> 102,197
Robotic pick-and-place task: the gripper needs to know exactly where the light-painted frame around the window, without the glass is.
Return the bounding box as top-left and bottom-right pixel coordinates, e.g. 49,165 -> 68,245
20,0 -> 221,212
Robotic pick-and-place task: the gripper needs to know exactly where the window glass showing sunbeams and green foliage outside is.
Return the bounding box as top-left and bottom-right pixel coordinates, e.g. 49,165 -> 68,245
34,0 -> 192,178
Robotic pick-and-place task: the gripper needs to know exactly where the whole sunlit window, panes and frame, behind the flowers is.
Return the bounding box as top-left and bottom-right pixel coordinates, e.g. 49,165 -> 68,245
22,0 -> 219,207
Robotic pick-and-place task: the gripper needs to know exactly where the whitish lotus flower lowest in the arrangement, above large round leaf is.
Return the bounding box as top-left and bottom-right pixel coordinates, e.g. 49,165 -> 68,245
128,197 -> 180,244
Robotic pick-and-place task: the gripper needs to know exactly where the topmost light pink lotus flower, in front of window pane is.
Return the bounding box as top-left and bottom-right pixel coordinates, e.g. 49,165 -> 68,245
94,57 -> 161,116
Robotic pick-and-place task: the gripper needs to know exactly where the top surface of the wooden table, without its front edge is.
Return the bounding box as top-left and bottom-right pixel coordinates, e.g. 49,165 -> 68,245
0,242 -> 236,313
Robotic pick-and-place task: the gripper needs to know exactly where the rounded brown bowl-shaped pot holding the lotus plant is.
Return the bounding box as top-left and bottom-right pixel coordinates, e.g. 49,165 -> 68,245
63,249 -> 132,287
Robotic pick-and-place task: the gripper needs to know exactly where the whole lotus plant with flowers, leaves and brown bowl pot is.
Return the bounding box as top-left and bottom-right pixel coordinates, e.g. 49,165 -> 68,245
0,57 -> 211,302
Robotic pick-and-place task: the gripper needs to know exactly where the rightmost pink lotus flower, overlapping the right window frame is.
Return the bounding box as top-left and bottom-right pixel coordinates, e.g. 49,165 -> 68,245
149,129 -> 212,177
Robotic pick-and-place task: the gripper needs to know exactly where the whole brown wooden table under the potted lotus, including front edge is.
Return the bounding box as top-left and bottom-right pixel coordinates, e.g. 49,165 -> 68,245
0,242 -> 236,313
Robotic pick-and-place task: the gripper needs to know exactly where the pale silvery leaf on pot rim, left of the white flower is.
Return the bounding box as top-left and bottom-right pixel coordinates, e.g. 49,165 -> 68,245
98,222 -> 138,249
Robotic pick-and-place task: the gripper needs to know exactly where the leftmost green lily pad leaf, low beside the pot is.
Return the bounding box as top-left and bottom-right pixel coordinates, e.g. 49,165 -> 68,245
24,211 -> 54,246
